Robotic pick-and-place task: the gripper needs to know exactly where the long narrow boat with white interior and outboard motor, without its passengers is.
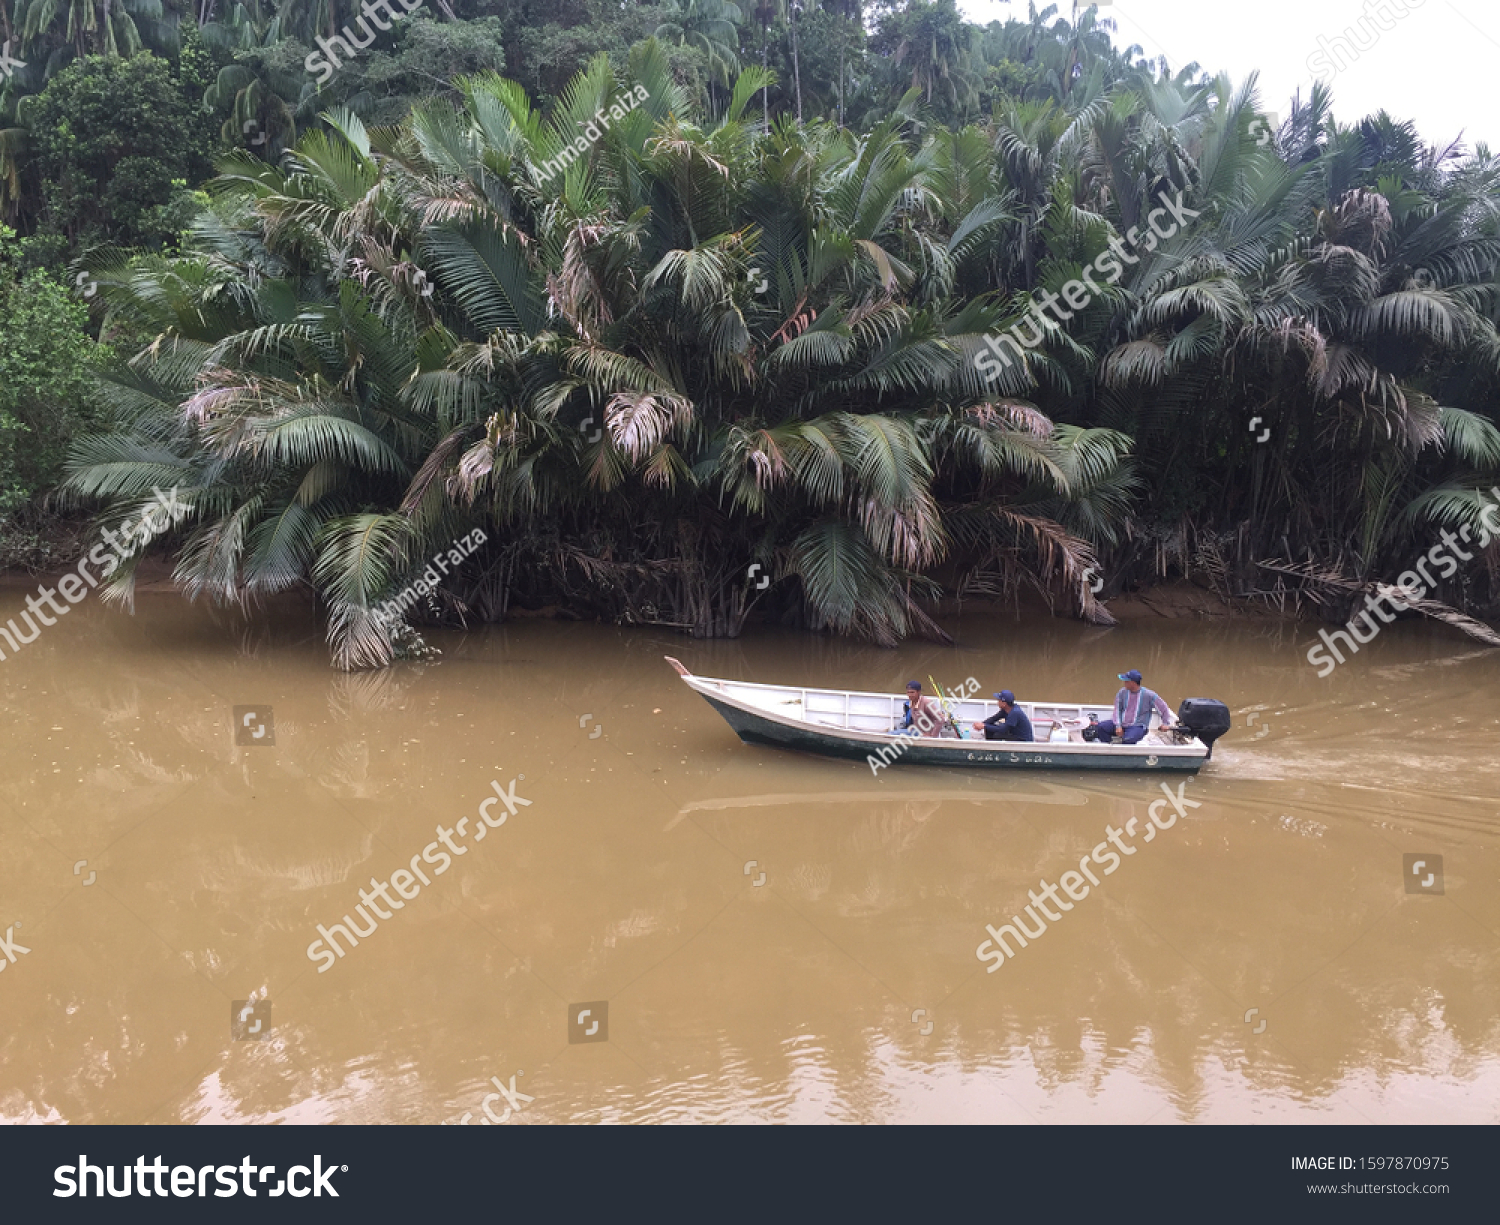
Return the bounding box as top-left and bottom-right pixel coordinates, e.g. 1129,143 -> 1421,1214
663,655 -> 1227,774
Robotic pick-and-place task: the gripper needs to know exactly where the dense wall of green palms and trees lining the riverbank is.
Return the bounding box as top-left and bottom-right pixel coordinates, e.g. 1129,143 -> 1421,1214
0,0 -> 1500,666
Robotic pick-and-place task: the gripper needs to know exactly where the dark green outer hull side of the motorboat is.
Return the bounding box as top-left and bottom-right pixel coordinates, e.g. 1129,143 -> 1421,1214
695,685 -> 1208,774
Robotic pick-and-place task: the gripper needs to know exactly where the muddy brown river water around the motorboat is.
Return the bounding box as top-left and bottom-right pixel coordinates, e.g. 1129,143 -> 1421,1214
0,589 -> 1500,1126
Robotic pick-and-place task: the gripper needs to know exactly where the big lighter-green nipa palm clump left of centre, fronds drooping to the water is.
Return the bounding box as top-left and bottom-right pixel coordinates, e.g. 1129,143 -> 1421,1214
68,43 -> 1127,666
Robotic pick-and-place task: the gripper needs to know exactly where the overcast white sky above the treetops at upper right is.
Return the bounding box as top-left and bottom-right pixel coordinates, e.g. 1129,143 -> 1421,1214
959,0 -> 1500,148
